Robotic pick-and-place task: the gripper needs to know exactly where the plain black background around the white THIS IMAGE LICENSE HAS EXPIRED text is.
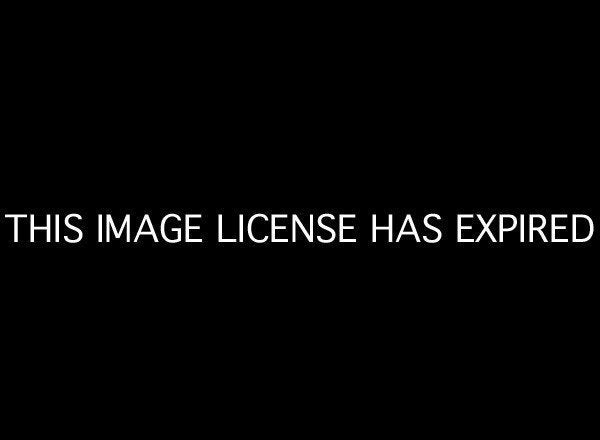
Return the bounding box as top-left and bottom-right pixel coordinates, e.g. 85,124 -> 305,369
1,5 -> 598,433
